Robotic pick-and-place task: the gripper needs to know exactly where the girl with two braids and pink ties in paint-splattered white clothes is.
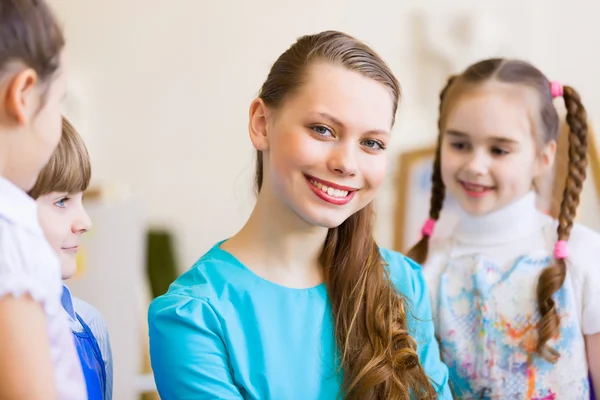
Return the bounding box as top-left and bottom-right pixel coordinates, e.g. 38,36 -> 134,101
409,59 -> 600,400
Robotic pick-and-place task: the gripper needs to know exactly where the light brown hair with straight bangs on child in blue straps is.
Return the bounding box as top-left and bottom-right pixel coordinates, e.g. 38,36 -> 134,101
29,117 -> 92,199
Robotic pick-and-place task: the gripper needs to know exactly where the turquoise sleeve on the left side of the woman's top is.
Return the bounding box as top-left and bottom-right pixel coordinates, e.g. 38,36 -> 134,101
148,293 -> 243,400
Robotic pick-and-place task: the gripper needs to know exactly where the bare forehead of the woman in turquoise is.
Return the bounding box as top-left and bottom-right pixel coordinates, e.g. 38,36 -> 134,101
284,62 -> 394,131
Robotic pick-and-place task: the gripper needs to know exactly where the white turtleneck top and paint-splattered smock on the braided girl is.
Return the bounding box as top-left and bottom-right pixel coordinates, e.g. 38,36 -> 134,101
424,193 -> 600,400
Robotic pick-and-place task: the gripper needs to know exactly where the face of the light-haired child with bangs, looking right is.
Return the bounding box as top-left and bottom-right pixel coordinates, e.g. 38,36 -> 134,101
36,192 -> 92,279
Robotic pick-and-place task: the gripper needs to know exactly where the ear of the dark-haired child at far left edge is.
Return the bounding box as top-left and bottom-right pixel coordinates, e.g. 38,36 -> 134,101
5,68 -> 38,124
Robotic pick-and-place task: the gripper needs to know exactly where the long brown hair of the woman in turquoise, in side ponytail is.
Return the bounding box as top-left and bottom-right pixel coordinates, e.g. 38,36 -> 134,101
256,31 -> 436,400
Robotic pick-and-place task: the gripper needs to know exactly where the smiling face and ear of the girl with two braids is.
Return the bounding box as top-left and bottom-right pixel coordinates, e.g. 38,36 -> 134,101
441,84 -> 556,215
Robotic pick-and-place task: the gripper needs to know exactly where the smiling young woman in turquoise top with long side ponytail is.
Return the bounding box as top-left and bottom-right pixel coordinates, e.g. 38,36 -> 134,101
149,31 -> 451,400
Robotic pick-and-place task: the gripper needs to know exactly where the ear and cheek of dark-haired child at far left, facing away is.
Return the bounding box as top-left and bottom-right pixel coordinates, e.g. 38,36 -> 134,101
3,54 -> 67,191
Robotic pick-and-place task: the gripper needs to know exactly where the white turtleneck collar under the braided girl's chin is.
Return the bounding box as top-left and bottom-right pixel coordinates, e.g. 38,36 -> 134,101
455,192 -> 540,245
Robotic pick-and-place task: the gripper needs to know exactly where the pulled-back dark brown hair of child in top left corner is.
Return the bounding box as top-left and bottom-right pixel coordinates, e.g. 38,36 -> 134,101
0,0 -> 65,81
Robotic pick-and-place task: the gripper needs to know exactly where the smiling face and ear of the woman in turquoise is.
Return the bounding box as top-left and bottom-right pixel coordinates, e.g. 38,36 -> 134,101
250,62 -> 393,228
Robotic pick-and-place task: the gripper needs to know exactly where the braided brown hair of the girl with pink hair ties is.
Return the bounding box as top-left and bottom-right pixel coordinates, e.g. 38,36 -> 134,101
408,59 -> 588,363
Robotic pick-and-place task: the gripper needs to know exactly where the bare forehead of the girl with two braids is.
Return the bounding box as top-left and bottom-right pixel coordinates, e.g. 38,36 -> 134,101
445,84 -> 539,141
